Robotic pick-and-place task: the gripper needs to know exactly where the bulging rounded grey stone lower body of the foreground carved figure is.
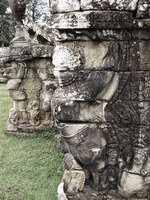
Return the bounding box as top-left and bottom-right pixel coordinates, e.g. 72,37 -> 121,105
60,124 -> 106,165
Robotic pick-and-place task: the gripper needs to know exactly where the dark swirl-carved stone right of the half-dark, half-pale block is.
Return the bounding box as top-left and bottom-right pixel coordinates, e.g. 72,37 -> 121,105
104,100 -> 150,127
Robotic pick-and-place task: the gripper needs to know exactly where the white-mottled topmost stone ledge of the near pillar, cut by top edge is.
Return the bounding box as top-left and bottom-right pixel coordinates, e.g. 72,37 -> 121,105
51,0 -> 150,18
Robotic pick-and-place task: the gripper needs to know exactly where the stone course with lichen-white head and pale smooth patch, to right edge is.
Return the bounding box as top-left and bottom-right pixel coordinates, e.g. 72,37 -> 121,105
53,38 -> 150,72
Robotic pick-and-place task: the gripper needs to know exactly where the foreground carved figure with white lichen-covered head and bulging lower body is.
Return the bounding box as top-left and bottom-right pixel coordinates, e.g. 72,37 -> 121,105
52,43 -> 123,199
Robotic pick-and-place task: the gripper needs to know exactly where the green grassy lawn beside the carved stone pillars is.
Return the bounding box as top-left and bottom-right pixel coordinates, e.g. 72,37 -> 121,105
0,85 -> 63,200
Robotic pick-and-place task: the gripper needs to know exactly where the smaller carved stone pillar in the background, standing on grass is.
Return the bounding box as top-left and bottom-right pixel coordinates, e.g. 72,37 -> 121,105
1,44 -> 56,134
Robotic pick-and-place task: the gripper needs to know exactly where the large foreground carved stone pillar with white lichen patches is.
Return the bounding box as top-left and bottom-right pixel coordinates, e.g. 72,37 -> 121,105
51,0 -> 150,200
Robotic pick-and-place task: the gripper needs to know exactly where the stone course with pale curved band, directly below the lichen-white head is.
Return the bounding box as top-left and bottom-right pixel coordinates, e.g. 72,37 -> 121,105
55,70 -> 150,102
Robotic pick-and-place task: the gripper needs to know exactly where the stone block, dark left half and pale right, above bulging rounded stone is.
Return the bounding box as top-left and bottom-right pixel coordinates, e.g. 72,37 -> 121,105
51,101 -> 107,123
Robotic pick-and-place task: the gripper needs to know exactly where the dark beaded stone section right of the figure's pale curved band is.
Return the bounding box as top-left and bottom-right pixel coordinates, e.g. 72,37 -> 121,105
113,71 -> 150,101
